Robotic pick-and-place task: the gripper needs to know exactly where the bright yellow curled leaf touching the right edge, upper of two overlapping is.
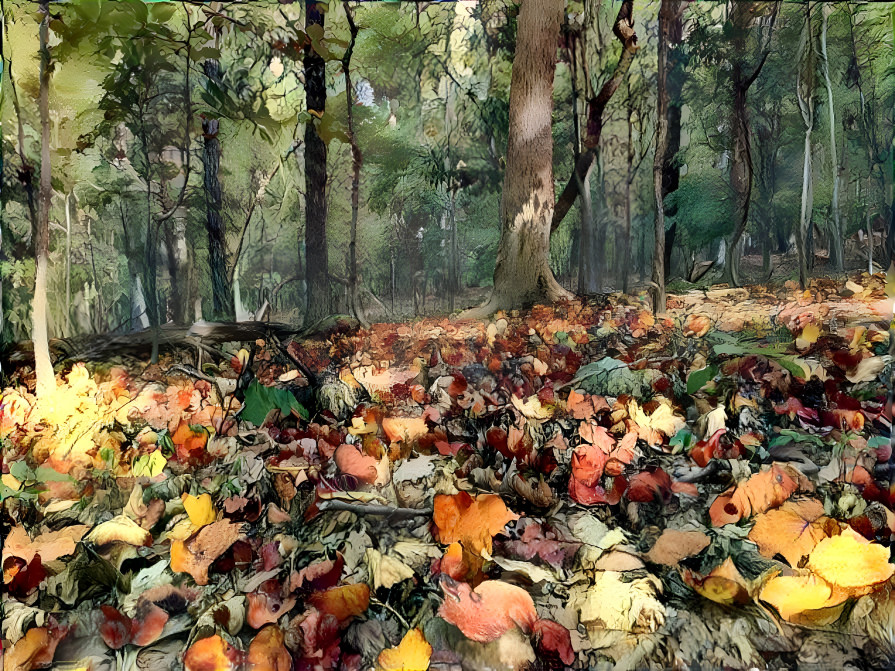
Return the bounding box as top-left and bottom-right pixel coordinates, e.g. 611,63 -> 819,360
808,530 -> 895,596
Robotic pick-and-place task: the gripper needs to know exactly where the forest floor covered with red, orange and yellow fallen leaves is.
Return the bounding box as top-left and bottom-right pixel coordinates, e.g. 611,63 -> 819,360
0,274 -> 895,671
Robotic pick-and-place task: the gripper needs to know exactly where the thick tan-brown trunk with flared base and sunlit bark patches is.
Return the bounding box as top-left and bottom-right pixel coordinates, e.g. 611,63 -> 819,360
465,0 -> 571,317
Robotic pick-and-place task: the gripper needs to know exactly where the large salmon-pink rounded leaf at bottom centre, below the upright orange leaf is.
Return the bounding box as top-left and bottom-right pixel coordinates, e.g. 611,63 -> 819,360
438,578 -> 538,643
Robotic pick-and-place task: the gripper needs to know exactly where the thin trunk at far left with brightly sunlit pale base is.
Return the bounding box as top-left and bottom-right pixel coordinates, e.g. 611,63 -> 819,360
31,0 -> 56,397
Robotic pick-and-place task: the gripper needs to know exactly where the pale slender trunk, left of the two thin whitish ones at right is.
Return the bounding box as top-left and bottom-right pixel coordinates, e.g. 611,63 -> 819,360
796,2 -> 814,289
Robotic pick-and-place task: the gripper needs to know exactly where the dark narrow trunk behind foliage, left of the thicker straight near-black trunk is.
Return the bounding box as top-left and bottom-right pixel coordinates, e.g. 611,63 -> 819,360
202,75 -> 236,321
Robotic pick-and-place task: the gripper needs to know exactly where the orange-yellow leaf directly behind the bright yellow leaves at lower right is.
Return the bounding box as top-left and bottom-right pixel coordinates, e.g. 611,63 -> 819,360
749,499 -> 839,567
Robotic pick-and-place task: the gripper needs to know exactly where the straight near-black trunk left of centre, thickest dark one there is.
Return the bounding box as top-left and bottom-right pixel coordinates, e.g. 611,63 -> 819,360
304,0 -> 330,326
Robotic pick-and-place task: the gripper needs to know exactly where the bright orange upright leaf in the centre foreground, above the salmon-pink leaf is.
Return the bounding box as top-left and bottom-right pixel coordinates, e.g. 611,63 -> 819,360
432,492 -> 519,554
